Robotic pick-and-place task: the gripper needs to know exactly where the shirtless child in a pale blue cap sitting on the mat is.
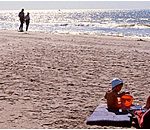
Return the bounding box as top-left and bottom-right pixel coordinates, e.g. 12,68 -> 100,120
105,78 -> 129,110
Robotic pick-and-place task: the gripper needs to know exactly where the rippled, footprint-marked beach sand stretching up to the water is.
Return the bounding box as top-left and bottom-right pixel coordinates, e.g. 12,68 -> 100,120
0,30 -> 150,129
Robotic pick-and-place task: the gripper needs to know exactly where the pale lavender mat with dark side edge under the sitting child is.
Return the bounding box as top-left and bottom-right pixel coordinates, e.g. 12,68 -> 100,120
86,105 -> 132,127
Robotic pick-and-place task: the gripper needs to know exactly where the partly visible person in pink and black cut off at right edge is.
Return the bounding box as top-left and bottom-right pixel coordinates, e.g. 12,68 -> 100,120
135,96 -> 150,129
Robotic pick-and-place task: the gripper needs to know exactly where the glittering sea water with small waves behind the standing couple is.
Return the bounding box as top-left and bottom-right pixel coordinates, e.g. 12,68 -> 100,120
0,9 -> 150,38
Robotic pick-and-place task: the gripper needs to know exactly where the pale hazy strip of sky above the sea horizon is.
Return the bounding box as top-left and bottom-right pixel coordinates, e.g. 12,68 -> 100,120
0,0 -> 150,10
